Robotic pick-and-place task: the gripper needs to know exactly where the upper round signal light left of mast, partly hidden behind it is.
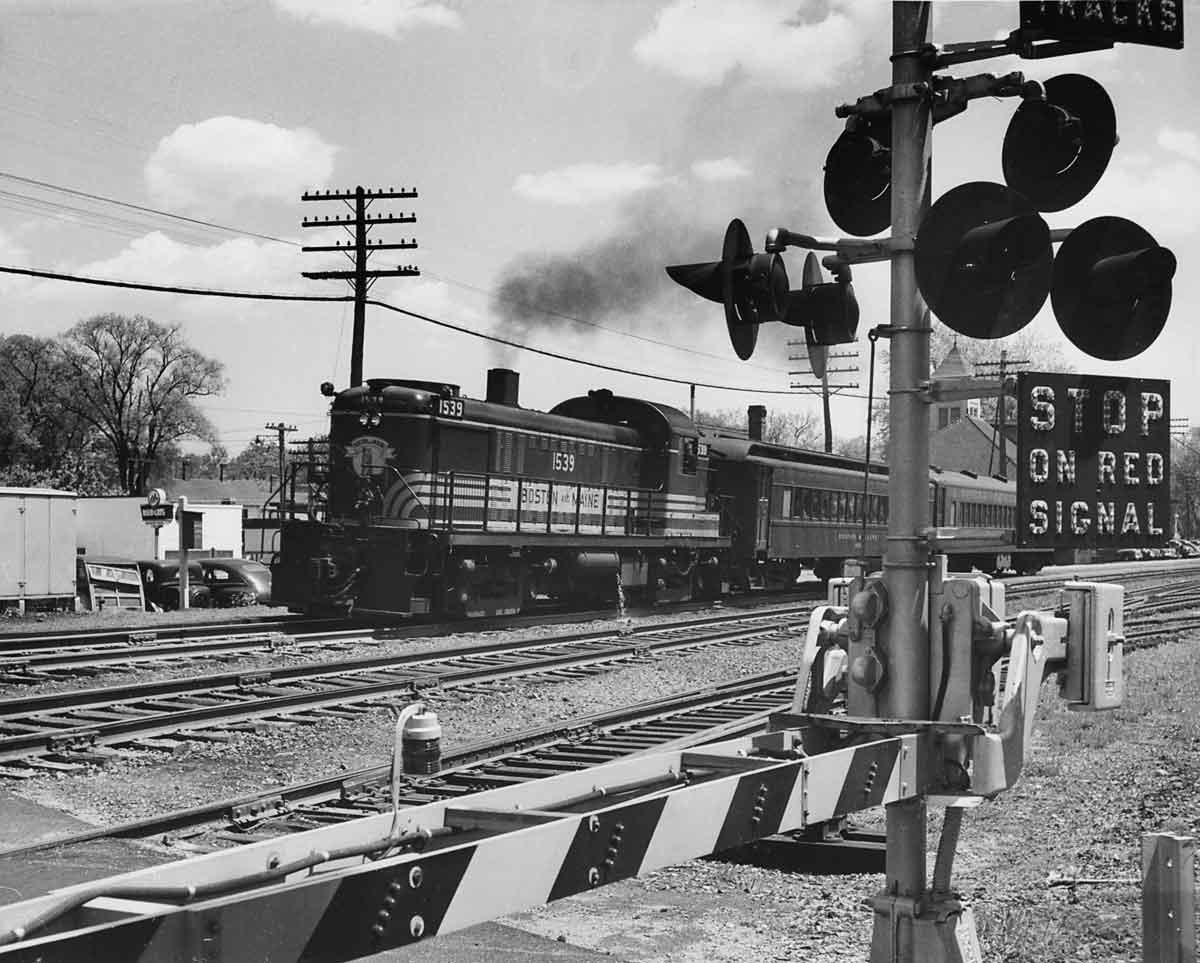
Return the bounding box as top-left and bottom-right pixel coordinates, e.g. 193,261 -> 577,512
824,115 -> 892,238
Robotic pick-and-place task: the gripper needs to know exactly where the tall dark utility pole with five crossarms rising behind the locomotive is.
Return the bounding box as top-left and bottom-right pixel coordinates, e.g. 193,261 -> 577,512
300,186 -> 420,388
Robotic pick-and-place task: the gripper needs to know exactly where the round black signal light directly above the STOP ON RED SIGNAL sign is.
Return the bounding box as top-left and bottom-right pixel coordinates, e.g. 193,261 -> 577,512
1050,217 -> 1176,361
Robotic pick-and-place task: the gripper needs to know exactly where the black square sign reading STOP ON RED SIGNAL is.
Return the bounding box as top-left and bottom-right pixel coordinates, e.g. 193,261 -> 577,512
1016,371 -> 1171,549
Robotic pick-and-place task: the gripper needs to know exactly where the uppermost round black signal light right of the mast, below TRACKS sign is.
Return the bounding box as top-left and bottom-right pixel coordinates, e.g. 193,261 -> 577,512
1001,73 -> 1117,211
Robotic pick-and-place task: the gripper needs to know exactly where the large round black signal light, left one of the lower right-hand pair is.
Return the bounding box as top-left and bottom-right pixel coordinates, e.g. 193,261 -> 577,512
913,181 -> 1054,339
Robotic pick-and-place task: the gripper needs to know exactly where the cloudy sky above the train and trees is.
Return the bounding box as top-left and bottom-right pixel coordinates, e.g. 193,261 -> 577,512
0,0 -> 1200,453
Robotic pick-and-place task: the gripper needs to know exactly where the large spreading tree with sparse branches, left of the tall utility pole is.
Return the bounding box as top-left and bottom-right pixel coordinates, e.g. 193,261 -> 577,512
60,315 -> 224,495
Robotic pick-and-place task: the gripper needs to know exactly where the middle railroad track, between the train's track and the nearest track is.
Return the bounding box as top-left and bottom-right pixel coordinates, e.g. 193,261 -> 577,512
0,610 -> 799,778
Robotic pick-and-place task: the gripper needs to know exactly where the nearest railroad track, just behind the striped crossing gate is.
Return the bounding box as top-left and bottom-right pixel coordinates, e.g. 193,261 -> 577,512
0,666 -> 796,860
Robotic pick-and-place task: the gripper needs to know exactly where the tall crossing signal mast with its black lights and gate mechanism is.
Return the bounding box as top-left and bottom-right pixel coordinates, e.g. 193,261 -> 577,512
667,0 -> 1183,963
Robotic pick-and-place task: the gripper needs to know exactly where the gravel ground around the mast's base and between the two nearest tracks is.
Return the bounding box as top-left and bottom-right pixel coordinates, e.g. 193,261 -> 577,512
4,607 -> 1200,963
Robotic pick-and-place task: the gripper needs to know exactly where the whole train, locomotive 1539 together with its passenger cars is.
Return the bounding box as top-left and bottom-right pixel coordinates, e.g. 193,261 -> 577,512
272,369 -> 1041,616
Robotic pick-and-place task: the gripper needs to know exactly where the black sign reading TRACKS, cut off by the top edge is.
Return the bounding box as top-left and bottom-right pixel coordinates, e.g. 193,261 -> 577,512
1021,0 -> 1184,50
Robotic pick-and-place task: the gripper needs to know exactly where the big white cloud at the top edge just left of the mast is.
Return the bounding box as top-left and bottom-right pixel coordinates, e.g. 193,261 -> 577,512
634,0 -> 890,90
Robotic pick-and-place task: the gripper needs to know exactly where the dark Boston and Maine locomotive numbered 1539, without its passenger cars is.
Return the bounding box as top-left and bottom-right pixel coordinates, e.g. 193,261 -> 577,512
272,369 -> 727,616
